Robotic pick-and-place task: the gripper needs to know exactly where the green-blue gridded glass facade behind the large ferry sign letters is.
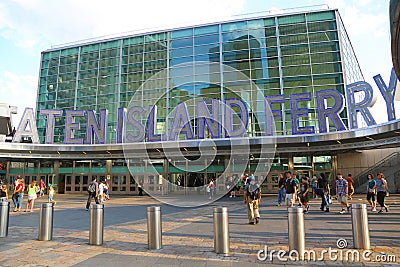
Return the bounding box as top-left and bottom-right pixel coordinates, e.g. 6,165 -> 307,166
37,10 -> 363,143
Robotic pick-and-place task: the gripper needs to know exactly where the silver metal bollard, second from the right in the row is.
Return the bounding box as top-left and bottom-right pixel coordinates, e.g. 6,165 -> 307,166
288,207 -> 306,256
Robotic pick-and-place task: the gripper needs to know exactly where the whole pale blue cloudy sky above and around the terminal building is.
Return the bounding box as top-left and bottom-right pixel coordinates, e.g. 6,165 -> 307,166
0,0 -> 394,124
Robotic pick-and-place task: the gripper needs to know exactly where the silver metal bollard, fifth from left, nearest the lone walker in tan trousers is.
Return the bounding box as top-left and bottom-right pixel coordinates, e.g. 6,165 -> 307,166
214,207 -> 230,255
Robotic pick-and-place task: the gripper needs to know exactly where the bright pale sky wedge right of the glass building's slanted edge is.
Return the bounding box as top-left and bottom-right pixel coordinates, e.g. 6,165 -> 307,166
326,0 -> 398,123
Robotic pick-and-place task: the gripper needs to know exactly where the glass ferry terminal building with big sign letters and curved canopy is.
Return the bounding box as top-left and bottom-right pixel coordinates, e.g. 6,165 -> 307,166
0,9 -> 400,198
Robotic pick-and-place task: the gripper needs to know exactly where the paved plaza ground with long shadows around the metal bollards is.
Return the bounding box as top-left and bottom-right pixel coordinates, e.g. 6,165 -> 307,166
0,195 -> 400,266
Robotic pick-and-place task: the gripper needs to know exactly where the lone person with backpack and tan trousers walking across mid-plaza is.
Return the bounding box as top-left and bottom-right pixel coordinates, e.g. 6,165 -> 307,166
244,175 -> 261,224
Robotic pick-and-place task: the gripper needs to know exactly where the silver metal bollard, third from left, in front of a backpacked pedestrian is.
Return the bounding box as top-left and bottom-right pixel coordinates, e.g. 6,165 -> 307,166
89,204 -> 104,246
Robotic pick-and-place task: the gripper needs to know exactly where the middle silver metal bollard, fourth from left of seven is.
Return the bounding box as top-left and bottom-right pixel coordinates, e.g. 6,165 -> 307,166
147,207 -> 162,249
